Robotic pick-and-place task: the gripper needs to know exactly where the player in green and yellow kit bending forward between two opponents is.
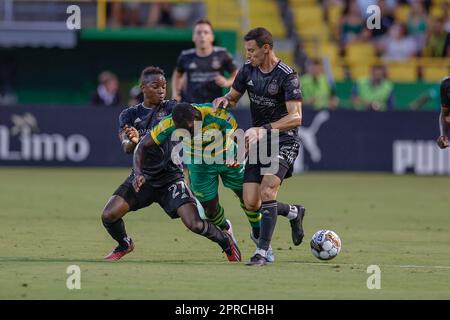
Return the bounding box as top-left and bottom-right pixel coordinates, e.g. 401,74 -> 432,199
135,103 -> 274,261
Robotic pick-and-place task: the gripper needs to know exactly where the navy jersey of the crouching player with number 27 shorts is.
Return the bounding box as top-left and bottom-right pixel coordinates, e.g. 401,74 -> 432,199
119,100 -> 183,187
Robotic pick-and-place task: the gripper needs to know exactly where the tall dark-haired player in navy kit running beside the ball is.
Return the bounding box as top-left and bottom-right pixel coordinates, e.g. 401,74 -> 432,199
214,28 -> 305,266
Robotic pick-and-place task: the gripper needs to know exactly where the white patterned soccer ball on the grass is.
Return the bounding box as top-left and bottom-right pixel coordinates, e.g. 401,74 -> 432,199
310,230 -> 341,260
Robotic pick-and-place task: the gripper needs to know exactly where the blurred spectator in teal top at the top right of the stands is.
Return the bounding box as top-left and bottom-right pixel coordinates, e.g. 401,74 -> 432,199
406,0 -> 427,51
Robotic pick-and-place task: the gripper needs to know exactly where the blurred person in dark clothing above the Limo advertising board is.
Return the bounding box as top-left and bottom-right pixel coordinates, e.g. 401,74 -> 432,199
91,71 -> 122,107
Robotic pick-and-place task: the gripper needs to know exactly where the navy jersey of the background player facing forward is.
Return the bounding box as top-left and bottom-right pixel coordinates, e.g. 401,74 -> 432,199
176,47 -> 237,103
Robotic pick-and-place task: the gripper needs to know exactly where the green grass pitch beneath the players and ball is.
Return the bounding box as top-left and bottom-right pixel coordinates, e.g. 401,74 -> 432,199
0,168 -> 450,300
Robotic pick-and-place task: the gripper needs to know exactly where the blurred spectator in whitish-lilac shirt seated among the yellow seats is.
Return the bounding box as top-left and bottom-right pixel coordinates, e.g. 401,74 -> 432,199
377,23 -> 417,61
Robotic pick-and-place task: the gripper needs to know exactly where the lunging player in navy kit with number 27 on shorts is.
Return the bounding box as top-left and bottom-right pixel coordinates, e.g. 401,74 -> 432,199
102,67 -> 240,261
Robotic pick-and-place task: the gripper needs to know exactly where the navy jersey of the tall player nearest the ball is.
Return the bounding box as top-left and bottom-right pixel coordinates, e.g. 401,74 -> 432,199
233,60 -> 302,141
